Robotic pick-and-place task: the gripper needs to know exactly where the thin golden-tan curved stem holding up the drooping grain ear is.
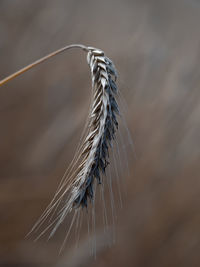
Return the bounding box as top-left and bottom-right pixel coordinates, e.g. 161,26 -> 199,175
0,44 -> 88,86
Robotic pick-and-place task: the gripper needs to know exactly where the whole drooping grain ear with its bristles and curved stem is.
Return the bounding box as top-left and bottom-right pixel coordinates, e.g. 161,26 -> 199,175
0,45 -> 119,239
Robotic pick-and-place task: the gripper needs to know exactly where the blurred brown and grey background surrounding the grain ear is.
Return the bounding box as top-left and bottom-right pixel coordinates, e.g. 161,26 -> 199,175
0,0 -> 200,267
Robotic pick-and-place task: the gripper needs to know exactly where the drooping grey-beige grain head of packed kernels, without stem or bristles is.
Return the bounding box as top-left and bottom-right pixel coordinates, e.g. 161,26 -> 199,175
70,47 -> 119,207
